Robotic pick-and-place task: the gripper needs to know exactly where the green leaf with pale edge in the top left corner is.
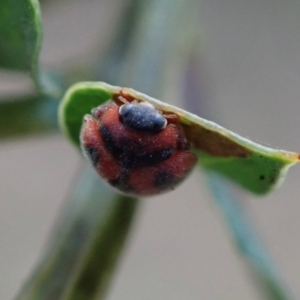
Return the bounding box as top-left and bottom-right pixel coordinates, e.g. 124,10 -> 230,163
0,0 -> 42,77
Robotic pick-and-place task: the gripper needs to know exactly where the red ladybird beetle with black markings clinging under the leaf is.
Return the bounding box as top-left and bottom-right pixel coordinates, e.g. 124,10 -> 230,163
80,96 -> 197,196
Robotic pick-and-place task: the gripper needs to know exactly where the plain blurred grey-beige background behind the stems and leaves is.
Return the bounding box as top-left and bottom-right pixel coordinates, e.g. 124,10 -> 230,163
0,0 -> 300,300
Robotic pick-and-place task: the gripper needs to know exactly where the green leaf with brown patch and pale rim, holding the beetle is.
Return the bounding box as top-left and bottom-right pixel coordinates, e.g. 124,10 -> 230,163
59,82 -> 299,195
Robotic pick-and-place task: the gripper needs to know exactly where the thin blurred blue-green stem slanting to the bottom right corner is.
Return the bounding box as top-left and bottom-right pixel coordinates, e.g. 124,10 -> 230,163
206,171 -> 293,300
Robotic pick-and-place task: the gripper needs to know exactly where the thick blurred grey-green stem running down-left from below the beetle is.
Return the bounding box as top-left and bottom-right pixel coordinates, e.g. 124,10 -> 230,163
17,169 -> 137,300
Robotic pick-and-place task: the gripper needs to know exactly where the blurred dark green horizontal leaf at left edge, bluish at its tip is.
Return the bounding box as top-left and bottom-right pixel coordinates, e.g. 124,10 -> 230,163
0,96 -> 58,139
